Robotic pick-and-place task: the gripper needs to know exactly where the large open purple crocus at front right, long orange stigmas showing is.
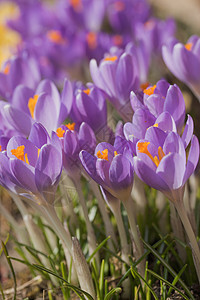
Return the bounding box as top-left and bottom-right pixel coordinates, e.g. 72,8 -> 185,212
134,125 -> 199,202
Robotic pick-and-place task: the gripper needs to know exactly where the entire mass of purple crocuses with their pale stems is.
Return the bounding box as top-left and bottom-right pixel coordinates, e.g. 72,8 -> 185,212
0,0 -> 200,297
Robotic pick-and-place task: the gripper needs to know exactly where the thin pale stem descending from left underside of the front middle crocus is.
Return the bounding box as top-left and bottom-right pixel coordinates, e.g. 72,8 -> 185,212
90,181 -> 117,251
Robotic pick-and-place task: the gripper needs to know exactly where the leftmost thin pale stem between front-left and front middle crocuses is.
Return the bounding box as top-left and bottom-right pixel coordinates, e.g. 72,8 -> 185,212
73,179 -> 100,265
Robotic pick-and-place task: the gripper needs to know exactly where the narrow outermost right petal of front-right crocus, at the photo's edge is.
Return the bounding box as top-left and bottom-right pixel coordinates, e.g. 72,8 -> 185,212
183,135 -> 199,184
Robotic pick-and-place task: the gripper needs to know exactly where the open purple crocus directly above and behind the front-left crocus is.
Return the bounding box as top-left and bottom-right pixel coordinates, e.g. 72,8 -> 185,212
3,79 -> 73,136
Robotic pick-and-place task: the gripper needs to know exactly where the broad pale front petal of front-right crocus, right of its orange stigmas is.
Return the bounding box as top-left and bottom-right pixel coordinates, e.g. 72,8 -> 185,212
156,153 -> 186,190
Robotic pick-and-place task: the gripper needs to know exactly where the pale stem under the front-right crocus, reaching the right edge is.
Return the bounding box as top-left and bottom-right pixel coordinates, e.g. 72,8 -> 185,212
174,201 -> 200,282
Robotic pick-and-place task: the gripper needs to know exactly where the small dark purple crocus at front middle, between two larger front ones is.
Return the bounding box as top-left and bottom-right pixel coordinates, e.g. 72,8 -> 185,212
80,140 -> 134,201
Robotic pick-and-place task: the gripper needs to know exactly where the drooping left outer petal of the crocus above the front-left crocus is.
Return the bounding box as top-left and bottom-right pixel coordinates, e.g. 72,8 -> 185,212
3,104 -> 34,136
